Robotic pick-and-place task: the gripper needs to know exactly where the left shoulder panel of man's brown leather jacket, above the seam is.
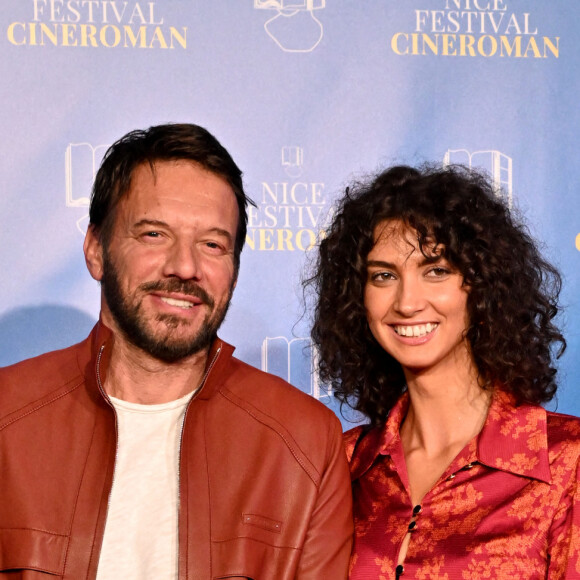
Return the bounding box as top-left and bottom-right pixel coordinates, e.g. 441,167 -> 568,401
0,339 -> 88,417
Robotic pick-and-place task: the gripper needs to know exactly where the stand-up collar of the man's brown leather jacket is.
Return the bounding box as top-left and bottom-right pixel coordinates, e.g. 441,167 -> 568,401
89,319 -> 235,399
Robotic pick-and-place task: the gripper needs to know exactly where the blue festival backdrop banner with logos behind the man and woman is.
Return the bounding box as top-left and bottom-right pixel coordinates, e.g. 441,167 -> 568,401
0,0 -> 580,426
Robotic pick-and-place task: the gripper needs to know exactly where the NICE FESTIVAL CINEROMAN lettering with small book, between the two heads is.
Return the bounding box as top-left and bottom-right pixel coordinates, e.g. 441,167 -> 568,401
246,145 -> 328,252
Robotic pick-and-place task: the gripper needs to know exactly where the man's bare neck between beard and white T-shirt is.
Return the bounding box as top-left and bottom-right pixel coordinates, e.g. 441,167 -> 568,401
104,337 -> 208,405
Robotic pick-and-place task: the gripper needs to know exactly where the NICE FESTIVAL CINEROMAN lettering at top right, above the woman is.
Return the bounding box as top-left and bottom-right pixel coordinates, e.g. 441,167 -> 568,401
391,0 -> 560,58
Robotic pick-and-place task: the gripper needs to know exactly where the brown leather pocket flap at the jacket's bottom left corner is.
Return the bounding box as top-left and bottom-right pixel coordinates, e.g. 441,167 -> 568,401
0,528 -> 68,576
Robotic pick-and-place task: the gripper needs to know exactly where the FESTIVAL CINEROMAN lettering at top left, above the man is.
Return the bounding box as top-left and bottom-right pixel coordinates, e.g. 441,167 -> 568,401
6,0 -> 187,49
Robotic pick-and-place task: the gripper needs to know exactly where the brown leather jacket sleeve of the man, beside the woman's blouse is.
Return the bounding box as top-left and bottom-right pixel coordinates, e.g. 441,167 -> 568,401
296,416 -> 353,580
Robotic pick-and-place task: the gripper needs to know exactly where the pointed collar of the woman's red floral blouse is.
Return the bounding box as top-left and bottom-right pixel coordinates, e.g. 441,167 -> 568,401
351,389 -> 552,483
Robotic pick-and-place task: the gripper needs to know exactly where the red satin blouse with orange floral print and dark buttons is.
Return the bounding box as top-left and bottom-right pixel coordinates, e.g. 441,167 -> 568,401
345,391 -> 580,580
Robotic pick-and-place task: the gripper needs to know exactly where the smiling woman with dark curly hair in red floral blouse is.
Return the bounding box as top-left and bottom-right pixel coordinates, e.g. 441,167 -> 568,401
310,167 -> 580,580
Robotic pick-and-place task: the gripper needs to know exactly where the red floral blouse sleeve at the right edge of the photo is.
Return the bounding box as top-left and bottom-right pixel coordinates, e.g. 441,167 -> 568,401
547,446 -> 580,580
